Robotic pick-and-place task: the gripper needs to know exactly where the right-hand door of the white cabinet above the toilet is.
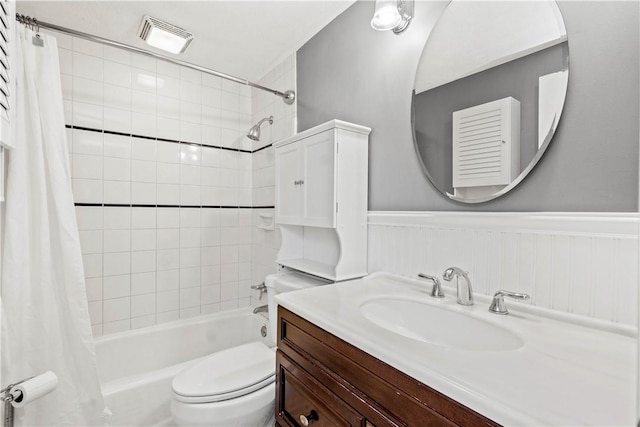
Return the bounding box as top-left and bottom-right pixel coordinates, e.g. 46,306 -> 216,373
301,130 -> 336,227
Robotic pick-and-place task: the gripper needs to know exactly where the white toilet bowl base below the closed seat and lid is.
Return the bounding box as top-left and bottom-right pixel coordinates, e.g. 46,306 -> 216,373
171,382 -> 276,427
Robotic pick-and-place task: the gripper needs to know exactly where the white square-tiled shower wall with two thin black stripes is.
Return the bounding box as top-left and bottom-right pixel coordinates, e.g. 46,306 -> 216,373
55,34 -> 295,335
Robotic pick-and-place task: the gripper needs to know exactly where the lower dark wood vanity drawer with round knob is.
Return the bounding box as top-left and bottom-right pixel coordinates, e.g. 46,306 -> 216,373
276,351 -> 364,427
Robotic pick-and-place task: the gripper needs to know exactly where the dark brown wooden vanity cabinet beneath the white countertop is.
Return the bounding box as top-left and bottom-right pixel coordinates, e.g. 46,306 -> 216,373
276,307 -> 499,427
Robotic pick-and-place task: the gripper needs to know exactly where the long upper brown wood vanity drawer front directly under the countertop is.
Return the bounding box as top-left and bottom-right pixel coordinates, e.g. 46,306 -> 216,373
278,307 -> 499,427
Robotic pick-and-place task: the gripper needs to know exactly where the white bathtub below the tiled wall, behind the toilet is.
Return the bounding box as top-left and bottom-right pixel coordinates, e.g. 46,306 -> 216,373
95,308 -> 267,426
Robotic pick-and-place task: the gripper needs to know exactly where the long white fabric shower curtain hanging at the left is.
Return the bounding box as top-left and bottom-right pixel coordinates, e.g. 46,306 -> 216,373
1,27 -> 108,426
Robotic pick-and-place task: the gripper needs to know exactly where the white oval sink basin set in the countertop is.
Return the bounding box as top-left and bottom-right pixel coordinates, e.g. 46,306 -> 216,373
360,298 -> 523,351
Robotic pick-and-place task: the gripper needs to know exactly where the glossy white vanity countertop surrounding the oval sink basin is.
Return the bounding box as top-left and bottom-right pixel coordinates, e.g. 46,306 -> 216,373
276,273 -> 637,426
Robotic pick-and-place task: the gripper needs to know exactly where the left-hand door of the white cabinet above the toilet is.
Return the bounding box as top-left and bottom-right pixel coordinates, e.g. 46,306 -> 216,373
275,143 -> 302,225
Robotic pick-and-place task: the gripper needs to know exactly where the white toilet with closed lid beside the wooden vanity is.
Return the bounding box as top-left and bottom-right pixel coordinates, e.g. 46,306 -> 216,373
171,272 -> 325,427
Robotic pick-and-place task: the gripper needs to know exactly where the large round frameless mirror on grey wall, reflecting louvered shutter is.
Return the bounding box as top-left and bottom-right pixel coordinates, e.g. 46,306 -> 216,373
412,0 -> 569,203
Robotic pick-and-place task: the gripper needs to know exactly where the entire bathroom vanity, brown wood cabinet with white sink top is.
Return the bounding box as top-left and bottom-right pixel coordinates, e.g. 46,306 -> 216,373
276,273 -> 636,427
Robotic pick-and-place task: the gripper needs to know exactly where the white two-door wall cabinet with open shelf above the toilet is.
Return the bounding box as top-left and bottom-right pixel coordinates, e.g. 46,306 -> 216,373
274,120 -> 371,281
